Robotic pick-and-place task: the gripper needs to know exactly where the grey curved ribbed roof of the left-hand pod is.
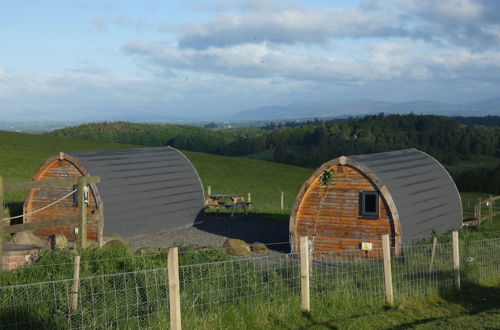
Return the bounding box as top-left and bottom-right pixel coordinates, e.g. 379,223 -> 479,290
68,147 -> 204,237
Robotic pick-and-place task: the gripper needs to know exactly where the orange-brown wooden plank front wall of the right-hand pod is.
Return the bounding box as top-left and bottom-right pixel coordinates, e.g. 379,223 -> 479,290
292,164 -> 394,256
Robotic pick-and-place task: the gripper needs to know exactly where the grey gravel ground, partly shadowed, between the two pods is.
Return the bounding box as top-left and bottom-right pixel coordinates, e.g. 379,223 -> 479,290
125,214 -> 289,252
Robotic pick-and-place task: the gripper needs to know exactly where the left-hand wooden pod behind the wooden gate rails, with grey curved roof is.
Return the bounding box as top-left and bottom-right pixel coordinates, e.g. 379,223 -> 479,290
24,147 -> 204,240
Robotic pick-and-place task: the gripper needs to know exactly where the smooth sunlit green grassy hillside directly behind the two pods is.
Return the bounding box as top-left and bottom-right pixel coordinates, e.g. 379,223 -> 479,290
0,131 -> 312,217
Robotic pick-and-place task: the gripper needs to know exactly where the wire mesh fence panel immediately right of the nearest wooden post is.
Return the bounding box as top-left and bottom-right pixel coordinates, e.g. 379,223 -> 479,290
179,254 -> 300,319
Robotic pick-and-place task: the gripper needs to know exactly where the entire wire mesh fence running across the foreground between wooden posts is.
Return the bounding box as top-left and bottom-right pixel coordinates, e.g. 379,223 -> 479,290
0,239 -> 500,329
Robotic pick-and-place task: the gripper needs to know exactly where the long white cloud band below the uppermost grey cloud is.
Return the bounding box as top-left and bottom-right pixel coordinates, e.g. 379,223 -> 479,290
125,40 -> 500,84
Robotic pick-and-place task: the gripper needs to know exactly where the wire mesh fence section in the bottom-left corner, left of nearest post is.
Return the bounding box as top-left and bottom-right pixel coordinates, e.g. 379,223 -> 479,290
0,268 -> 168,329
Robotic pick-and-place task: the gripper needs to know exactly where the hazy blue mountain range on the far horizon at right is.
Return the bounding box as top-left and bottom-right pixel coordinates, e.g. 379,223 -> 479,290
224,97 -> 500,121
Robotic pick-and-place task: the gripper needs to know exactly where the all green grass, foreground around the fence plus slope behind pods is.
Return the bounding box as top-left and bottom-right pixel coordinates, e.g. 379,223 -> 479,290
0,132 -> 500,329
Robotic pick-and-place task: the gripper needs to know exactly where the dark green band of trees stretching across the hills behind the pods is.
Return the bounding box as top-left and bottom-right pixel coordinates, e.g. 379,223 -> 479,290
50,114 -> 500,193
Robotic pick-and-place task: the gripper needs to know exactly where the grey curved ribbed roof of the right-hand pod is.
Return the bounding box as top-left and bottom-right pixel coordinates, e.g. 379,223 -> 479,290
347,149 -> 463,242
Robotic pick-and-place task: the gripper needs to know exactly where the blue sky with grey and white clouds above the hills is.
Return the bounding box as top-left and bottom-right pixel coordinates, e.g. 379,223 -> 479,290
0,0 -> 500,122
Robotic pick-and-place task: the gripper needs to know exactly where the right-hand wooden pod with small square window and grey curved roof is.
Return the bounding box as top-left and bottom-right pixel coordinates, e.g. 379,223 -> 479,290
290,149 -> 462,256
